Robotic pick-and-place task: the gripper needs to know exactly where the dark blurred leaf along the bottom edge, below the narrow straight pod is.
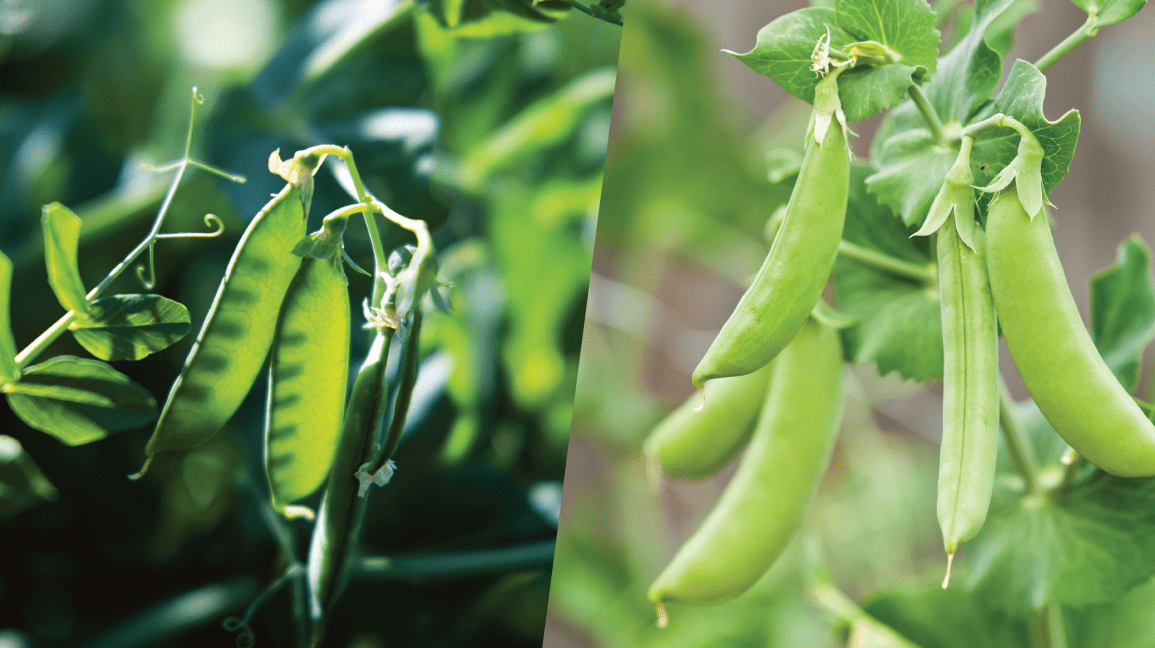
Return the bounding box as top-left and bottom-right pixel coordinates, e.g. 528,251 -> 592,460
863,586 -> 1030,648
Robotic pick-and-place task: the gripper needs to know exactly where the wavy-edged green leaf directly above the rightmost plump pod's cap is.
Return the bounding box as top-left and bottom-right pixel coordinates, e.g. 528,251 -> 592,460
970,59 -> 1080,202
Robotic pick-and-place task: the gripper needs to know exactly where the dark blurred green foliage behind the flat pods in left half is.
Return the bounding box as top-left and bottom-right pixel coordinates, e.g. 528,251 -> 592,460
0,0 -> 621,647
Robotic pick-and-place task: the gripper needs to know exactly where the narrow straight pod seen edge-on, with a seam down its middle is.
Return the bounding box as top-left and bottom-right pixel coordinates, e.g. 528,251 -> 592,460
937,216 -> 999,556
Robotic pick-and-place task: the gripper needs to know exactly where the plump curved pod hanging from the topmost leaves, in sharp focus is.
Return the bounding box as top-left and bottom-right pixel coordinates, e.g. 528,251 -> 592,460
693,120 -> 850,387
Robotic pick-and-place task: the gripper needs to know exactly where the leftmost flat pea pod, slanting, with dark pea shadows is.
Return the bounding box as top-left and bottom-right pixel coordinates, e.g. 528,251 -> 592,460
141,182 -> 312,464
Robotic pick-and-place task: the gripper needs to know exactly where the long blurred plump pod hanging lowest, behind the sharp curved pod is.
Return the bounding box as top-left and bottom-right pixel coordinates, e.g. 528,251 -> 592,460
649,320 -> 842,619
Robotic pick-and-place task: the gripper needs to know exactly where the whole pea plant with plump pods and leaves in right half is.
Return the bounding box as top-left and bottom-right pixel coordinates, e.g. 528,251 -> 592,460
561,0 -> 1155,646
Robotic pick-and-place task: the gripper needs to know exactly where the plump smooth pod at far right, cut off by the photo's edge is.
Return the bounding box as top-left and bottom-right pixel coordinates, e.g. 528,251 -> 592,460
986,192 -> 1155,477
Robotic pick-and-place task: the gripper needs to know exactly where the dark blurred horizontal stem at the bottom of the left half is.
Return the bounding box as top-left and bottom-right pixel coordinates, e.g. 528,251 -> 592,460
355,539 -> 554,581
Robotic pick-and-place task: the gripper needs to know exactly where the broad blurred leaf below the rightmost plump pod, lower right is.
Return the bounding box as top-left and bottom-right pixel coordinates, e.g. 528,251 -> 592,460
969,468 -> 1155,612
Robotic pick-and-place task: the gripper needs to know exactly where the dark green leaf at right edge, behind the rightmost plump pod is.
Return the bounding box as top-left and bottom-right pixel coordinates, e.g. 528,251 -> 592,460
1090,234 -> 1155,392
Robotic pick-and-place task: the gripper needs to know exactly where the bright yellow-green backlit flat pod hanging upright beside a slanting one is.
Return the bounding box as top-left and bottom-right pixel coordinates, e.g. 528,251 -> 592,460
264,252 -> 349,512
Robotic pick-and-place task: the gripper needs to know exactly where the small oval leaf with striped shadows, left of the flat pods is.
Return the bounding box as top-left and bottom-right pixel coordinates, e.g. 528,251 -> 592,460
69,295 -> 192,360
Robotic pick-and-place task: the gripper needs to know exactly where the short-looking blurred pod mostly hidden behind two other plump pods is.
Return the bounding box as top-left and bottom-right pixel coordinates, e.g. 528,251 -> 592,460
644,363 -> 774,479
